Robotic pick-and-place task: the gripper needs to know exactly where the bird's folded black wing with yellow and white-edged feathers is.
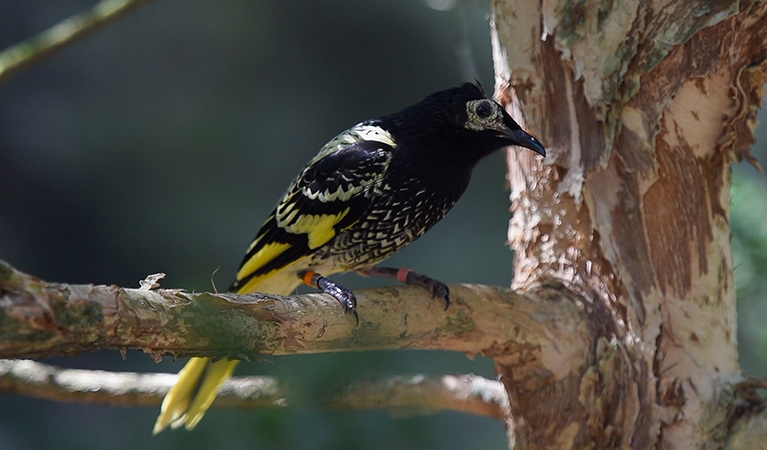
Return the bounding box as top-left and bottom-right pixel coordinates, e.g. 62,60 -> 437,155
232,135 -> 394,292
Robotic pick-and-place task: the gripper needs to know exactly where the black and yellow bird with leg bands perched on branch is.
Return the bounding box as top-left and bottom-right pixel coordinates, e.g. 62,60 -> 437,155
154,82 -> 546,434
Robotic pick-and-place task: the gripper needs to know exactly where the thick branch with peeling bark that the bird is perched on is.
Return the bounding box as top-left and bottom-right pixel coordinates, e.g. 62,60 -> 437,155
0,262 -> 590,366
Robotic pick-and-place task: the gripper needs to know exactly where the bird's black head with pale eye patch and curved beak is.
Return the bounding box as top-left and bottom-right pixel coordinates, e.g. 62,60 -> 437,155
382,83 -> 546,166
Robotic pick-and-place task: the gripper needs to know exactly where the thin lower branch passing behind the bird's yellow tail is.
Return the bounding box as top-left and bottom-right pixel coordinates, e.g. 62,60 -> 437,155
0,360 -> 509,418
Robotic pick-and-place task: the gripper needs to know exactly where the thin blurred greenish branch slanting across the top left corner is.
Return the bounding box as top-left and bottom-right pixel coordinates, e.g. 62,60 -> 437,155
0,0 -> 151,83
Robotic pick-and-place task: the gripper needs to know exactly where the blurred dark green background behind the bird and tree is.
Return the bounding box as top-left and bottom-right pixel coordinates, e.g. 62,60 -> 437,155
0,0 -> 767,450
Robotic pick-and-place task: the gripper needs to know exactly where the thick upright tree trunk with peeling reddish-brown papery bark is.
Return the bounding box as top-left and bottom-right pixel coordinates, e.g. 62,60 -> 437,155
491,0 -> 767,449
